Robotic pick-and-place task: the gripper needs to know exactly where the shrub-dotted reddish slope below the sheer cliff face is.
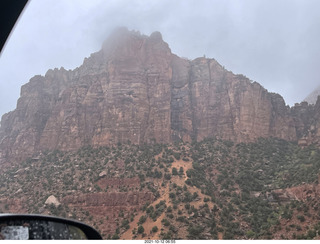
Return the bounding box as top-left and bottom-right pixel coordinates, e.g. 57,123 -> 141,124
0,138 -> 320,239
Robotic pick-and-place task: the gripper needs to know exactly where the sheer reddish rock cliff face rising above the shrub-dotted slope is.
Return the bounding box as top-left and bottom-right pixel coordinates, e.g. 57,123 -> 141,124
0,28 -> 319,162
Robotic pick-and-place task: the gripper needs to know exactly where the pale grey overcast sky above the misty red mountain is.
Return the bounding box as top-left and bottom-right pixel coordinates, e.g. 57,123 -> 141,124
0,0 -> 320,116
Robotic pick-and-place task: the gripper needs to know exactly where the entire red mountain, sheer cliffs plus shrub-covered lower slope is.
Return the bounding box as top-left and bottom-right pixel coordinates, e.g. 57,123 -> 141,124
0,28 -> 320,239
